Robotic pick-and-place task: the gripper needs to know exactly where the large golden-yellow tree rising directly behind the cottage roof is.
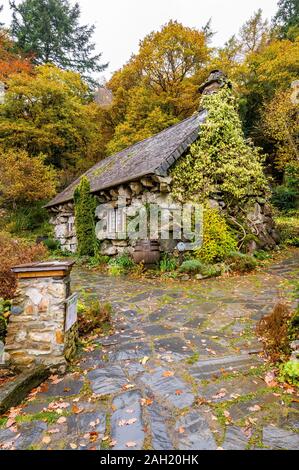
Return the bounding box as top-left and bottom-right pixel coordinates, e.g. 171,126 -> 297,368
106,21 -> 210,153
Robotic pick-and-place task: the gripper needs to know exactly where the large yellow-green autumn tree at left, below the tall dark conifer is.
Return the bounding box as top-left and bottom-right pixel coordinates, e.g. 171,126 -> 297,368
0,65 -> 105,179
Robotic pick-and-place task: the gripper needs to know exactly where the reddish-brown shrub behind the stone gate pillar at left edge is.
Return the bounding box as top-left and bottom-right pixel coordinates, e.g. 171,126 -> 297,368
0,232 -> 47,299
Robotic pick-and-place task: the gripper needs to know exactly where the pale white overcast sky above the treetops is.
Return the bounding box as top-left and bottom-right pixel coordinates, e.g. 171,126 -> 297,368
0,0 -> 277,78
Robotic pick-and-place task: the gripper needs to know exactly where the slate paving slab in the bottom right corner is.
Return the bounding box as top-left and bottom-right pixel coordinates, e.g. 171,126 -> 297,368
263,426 -> 299,450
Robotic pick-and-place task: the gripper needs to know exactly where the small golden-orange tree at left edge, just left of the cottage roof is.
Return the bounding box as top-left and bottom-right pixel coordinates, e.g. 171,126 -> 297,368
0,148 -> 57,206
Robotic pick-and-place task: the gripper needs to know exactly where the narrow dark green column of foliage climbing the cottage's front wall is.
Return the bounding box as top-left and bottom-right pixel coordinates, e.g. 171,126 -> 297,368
74,176 -> 97,256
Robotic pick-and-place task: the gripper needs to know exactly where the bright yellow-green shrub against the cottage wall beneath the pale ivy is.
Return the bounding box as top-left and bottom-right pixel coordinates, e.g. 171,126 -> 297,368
195,209 -> 237,263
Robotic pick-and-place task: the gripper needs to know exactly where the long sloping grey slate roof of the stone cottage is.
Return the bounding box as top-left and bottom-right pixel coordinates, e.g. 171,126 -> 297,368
46,110 -> 207,207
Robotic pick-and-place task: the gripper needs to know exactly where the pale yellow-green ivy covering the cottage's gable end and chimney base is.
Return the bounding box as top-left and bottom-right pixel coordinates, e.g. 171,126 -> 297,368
172,87 -> 268,206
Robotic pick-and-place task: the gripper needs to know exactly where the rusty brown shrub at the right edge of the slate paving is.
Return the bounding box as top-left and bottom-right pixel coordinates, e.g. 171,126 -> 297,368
256,302 -> 291,361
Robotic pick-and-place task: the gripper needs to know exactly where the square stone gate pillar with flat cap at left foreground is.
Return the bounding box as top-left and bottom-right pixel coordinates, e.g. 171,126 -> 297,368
5,261 -> 77,367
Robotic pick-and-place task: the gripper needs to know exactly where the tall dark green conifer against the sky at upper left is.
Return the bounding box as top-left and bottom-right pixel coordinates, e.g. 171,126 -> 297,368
10,0 -> 107,82
